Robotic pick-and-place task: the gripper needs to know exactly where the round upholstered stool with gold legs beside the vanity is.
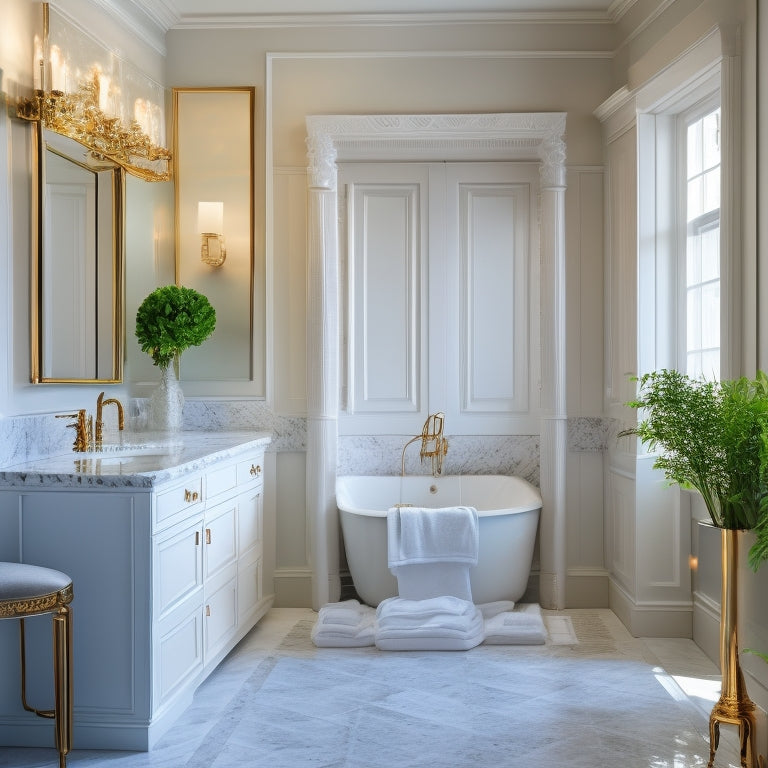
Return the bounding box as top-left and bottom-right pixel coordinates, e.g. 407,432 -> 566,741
0,563 -> 74,768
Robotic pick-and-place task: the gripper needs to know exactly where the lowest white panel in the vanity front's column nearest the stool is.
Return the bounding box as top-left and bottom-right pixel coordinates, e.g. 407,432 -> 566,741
155,604 -> 203,701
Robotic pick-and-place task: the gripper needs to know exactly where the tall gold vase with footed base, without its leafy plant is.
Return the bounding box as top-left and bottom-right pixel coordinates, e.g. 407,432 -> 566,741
708,528 -> 765,768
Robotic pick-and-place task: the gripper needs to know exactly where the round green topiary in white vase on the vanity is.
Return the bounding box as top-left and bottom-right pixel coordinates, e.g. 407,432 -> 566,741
136,285 -> 216,431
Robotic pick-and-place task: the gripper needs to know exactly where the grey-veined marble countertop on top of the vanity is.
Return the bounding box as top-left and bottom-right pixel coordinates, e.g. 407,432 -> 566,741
0,431 -> 272,490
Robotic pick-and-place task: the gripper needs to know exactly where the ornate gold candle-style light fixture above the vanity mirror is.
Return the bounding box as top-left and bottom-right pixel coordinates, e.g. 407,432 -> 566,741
17,3 -> 171,181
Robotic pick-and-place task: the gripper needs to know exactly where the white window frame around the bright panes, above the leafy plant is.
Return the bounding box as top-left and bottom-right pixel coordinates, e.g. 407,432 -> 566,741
635,51 -> 742,378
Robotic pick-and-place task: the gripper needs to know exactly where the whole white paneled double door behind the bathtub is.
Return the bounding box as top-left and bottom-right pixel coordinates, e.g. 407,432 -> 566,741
339,162 -> 539,434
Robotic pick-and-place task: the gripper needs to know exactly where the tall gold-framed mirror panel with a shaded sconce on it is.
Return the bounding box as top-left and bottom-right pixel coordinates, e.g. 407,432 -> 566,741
173,87 -> 255,382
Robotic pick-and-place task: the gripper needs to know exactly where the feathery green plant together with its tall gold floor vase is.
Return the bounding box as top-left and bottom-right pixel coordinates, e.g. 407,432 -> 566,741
620,369 -> 768,767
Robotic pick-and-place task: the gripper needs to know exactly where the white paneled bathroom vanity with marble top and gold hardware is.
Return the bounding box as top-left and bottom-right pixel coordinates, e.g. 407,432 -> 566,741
0,432 -> 274,750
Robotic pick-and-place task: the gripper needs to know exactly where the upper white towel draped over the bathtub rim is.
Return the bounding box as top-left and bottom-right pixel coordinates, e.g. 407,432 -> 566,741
387,507 -> 479,569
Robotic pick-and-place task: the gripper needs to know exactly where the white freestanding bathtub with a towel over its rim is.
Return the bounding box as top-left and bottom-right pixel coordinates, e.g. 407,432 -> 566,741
336,475 -> 541,606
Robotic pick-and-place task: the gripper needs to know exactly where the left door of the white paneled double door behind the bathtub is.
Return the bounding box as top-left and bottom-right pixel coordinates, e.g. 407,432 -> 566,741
339,163 -> 430,432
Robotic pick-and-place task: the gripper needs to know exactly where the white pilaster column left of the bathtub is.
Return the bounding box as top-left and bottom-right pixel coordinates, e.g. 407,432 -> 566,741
306,131 -> 340,610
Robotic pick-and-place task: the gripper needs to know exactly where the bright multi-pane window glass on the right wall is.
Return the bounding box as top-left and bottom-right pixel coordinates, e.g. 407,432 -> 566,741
680,107 -> 720,379
